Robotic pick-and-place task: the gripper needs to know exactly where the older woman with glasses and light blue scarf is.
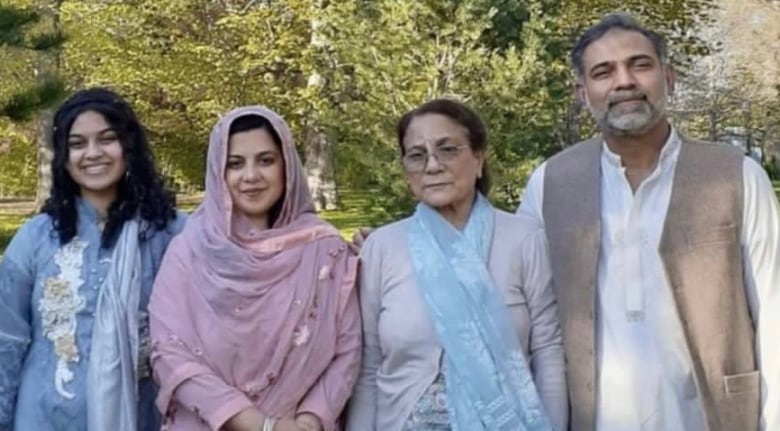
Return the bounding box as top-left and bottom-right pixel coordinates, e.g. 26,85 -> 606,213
347,99 -> 568,431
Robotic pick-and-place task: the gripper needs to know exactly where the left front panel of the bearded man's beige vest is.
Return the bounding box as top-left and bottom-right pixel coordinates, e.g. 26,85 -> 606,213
542,138 -> 602,431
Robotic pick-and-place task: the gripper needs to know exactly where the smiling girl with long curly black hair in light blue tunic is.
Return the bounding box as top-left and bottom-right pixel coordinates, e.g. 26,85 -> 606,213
0,88 -> 183,431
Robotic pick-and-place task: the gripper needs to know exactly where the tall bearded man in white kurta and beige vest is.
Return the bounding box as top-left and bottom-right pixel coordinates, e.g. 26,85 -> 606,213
518,14 -> 780,431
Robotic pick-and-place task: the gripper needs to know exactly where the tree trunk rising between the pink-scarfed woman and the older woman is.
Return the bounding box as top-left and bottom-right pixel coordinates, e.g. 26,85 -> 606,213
304,1 -> 338,211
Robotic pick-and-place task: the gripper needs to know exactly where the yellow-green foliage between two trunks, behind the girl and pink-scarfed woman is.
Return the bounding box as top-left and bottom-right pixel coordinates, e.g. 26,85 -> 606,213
62,0 -> 310,189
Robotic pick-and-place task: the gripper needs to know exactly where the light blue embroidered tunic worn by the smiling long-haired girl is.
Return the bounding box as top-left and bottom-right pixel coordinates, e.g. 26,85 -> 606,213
0,201 -> 184,431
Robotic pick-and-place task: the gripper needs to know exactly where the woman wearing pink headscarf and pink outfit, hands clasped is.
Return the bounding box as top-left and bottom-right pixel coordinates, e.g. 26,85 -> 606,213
149,107 -> 361,431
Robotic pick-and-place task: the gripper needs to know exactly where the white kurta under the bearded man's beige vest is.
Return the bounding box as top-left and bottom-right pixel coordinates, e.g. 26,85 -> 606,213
518,130 -> 780,431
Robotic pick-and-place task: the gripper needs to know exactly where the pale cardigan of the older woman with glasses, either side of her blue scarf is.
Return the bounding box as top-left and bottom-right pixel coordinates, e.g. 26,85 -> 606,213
347,211 -> 568,431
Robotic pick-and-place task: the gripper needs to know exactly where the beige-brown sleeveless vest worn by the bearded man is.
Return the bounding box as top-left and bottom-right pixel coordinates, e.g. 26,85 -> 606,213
543,138 -> 759,431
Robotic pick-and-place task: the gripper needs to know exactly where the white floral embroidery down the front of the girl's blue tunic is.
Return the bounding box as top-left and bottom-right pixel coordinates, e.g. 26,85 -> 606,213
38,238 -> 87,400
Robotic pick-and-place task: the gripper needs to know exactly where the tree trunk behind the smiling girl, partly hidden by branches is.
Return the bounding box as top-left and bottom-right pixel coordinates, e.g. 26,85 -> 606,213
35,0 -> 61,212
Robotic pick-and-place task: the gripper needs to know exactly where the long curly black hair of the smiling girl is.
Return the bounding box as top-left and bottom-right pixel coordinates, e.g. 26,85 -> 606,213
42,87 -> 176,248
